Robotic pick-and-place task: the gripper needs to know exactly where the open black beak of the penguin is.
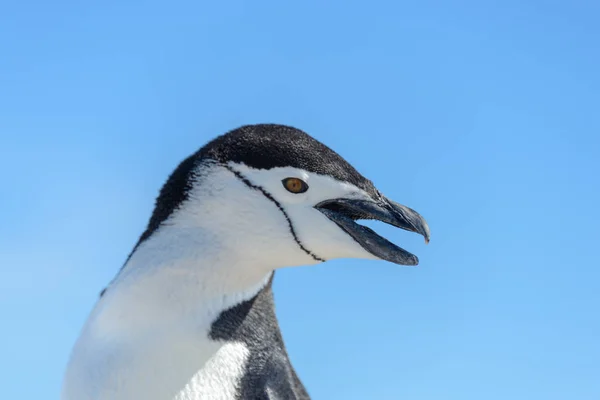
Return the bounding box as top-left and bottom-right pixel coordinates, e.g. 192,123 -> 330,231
315,196 -> 429,265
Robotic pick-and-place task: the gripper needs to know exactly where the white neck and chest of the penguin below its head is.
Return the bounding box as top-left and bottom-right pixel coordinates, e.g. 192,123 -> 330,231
63,226 -> 278,400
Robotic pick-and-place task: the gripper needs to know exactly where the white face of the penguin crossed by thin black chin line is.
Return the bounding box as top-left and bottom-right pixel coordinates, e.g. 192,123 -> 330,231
169,163 -> 376,269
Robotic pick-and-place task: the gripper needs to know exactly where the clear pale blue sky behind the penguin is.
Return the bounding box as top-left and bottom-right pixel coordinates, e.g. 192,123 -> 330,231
0,0 -> 600,400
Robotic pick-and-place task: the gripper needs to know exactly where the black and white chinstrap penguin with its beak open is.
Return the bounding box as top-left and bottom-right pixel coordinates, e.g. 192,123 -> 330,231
62,124 -> 429,400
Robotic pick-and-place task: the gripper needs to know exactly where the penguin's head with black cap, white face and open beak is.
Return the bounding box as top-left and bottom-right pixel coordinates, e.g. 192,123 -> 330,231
134,124 -> 429,269
